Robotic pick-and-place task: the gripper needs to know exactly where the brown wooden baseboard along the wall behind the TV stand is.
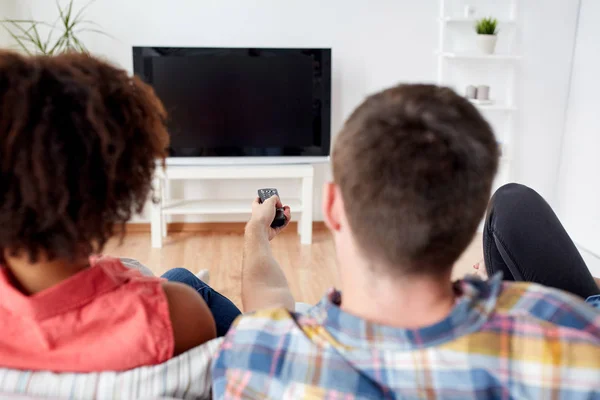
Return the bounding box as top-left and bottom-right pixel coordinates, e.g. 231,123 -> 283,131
125,221 -> 326,233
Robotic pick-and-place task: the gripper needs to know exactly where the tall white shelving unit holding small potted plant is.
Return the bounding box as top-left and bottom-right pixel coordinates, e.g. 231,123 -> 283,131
436,0 -> 521,181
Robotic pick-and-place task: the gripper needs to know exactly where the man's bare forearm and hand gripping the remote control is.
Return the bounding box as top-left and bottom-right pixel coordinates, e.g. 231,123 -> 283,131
242,196 -> 295,312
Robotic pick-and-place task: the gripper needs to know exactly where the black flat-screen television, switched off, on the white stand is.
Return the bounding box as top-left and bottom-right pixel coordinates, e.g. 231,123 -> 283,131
133,47 -> 331,157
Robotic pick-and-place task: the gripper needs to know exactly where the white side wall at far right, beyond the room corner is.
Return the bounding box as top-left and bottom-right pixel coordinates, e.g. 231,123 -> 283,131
557,0 -> 600,260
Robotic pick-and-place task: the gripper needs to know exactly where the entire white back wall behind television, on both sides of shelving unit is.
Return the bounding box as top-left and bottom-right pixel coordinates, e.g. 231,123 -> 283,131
7,0 -> 578,222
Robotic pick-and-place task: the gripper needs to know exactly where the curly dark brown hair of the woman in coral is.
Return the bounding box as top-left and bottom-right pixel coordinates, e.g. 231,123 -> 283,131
0,52 -> 169,262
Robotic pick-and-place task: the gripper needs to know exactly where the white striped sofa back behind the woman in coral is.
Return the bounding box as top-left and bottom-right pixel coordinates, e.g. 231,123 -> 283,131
0,338 -> 223,399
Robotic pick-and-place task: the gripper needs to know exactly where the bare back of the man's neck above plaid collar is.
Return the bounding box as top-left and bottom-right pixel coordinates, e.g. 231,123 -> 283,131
342,266 -> 455,329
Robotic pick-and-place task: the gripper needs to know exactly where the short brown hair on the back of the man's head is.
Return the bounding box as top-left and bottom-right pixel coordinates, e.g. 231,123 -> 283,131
333,85 -> 499,274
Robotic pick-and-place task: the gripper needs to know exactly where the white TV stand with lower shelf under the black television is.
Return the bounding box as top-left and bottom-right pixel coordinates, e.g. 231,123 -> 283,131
151,164 -> 314,248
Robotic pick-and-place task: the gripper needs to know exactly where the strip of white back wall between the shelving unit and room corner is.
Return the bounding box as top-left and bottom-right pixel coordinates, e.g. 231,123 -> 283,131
514,0 -> 580,202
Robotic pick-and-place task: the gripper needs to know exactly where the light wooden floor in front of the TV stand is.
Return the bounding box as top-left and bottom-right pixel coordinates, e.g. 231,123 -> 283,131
104,230 -> 482,307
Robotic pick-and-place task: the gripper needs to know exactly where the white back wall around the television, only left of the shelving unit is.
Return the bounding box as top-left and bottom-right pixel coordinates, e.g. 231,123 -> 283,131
10,0 -> 437,222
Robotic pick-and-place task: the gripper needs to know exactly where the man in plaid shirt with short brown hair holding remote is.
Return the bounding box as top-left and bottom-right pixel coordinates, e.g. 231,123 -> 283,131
213,85 -> 600,399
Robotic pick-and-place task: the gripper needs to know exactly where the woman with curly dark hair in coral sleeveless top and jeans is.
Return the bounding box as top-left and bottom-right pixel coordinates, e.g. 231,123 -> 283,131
0,52 -> 240,372
